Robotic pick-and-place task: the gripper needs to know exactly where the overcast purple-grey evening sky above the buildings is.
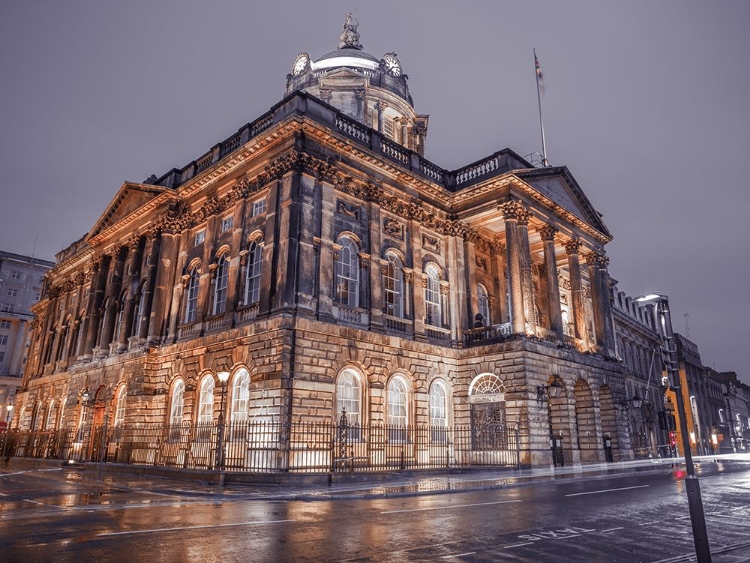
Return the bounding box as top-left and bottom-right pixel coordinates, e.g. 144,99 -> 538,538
0,0 -> 750,383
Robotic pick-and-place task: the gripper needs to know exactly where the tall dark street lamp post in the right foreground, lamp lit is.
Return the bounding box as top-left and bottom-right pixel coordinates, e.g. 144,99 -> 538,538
637,294 -> 711,563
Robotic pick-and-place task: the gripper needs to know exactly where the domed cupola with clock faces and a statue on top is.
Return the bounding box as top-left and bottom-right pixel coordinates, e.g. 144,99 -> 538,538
284,12 -> 429,159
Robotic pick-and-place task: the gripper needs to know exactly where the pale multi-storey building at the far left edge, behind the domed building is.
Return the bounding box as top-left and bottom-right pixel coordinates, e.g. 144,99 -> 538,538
0,251 -> 54,427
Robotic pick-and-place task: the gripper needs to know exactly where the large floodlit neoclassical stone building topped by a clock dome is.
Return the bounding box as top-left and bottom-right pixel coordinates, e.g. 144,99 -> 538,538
16,19 -> 636,465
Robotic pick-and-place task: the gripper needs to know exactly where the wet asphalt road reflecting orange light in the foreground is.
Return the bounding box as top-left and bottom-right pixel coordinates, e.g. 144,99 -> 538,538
0,464 -> 750,563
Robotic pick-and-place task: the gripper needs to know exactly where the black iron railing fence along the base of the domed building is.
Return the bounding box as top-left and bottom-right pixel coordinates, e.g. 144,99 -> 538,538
0,421 -> 520,472
